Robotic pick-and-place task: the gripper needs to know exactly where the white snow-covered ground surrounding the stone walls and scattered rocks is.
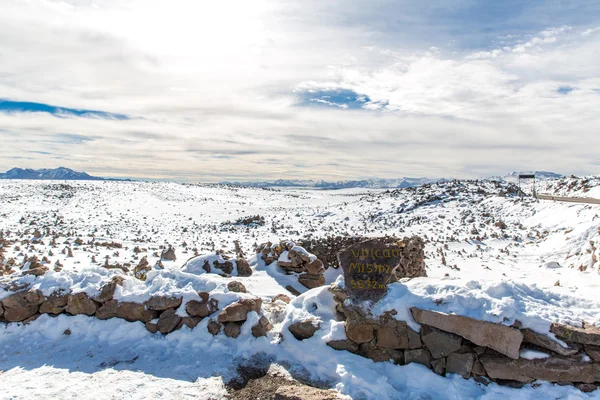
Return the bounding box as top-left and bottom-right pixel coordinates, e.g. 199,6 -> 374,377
0,178 -> 600,399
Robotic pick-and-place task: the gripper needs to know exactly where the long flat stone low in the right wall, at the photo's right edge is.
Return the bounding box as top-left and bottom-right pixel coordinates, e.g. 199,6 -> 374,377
479,353 -> 600,383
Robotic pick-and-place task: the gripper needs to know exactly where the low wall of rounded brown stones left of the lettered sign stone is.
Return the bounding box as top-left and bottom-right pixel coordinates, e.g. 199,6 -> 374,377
0,280 -> 276,338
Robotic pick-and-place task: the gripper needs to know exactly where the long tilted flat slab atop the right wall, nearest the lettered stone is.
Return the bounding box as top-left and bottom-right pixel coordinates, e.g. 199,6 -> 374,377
410,307 -> 523,359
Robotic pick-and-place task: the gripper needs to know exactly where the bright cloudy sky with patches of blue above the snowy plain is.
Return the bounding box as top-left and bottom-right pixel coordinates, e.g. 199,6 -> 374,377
0,0 -> 600,182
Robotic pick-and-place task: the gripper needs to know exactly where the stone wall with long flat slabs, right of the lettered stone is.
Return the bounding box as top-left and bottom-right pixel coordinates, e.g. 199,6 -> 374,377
327,287 -> 600,392
